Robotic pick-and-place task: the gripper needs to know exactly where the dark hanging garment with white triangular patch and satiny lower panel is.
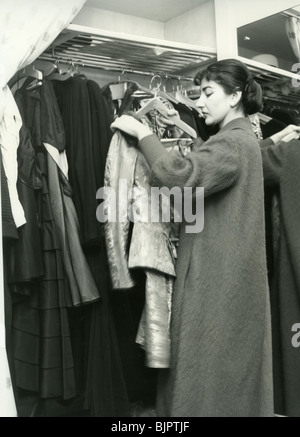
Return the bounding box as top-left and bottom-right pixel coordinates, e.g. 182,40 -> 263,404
40,81 -> 100,306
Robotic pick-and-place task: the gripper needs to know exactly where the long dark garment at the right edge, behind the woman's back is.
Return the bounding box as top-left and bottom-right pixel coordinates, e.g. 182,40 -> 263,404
261,139 -> 300,417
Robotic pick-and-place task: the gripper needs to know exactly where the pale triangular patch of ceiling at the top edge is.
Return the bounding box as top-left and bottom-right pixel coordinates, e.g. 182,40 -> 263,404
85,0 -> 208,22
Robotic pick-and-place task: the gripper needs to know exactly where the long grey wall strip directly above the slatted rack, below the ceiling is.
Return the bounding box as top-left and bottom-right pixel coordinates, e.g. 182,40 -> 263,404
72,6 -> 164,39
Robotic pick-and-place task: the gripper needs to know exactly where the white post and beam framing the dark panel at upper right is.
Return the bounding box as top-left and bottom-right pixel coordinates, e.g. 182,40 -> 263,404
215,0 -> 300,59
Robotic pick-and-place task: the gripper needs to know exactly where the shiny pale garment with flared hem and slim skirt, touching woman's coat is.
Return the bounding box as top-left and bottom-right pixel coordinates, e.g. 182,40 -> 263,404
128,140 -> 192,368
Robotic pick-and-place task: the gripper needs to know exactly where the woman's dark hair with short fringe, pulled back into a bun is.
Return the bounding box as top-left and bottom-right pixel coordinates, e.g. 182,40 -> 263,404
194,59 -> 263,115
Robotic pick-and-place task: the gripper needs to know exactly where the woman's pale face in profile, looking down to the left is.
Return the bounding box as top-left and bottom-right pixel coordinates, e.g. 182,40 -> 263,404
197,79 -> 234,128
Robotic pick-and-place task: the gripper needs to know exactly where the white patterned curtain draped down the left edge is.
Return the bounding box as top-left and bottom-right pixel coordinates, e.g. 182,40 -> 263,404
0,0 -> 86,417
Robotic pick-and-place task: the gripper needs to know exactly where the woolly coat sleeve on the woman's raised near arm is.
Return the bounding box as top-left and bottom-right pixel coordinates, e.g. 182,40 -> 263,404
140,133 -> 241,196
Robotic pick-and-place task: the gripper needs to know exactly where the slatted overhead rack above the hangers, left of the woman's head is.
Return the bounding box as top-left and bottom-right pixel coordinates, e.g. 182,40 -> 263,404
39,24 -> 216,75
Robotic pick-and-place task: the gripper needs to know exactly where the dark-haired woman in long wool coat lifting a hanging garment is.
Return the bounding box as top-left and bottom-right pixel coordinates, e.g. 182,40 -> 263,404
112,60 -> 273,417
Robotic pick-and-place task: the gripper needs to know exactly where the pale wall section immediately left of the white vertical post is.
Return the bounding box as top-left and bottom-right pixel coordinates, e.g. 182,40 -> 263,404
165,0 -> 217,48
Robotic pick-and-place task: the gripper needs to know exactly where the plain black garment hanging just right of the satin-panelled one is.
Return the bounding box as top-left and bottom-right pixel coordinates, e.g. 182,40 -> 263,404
53,76 -> 103,247
